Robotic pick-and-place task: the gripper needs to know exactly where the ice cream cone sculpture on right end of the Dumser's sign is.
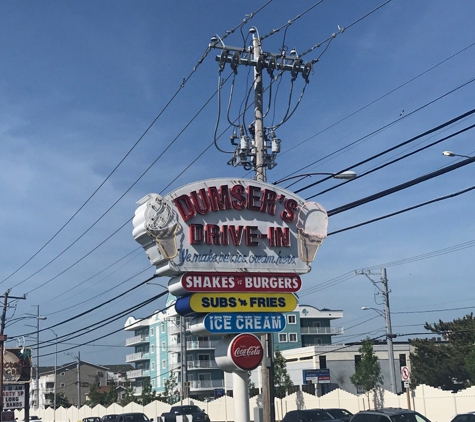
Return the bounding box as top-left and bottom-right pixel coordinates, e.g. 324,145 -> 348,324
297,202 -> 328,264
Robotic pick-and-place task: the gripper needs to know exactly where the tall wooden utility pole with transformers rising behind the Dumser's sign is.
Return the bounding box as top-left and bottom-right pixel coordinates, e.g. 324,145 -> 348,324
210,27 -> 312,422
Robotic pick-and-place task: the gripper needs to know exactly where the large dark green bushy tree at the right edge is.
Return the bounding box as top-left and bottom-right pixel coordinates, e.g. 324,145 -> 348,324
410,313 -> 475,391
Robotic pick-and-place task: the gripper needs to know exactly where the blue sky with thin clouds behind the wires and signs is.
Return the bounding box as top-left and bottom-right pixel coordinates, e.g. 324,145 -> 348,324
0,0 -> 475,364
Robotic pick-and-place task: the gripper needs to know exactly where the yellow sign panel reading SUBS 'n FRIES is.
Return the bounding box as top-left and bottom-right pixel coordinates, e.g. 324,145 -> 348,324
190,293 -> 297,313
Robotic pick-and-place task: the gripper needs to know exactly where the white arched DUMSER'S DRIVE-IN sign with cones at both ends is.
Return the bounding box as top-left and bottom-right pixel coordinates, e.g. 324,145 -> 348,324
133,179 -> 328,276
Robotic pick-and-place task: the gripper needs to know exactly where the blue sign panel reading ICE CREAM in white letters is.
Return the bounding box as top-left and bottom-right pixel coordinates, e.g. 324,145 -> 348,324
203,312 -> 285,334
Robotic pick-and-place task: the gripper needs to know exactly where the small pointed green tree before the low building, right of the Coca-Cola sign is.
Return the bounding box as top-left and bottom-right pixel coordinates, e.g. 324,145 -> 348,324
350,338 -> 383,404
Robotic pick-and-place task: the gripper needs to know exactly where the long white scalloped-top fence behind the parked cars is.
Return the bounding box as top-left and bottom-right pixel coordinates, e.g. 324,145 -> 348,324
15,385 -> 475,422
